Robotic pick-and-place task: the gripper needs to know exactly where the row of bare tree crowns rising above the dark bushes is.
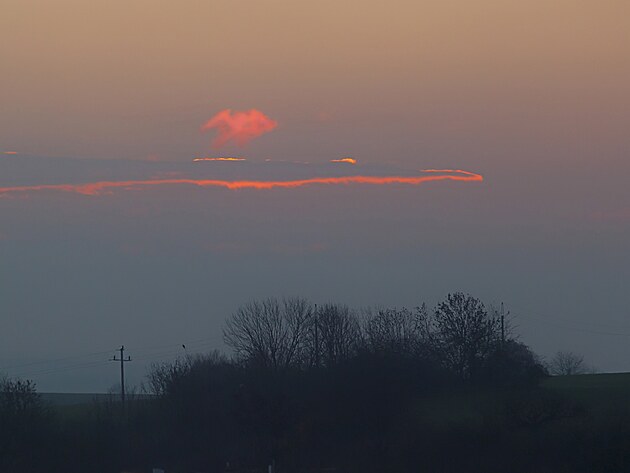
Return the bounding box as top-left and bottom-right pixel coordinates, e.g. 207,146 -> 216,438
224,293 -> 545,382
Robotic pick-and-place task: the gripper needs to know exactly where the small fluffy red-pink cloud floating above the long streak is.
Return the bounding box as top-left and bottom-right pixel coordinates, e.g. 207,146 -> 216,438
201,109 -> 278,147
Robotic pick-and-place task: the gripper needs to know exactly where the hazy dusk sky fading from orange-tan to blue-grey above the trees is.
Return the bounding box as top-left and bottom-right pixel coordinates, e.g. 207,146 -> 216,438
0,0 -> 630,392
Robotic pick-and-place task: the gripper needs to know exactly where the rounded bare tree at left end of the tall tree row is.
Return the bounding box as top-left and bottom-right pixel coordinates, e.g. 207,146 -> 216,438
223,298 -> 314,369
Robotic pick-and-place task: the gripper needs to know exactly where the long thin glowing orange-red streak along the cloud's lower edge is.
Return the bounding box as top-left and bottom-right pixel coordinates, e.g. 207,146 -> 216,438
0,169 -> 483,196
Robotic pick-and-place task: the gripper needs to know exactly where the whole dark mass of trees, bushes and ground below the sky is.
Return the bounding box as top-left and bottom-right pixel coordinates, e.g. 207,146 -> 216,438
0,293 -> 630,473
